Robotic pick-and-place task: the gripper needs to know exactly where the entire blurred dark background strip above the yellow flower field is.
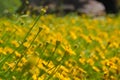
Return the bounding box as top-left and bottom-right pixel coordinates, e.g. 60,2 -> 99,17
0,0 -> 120,16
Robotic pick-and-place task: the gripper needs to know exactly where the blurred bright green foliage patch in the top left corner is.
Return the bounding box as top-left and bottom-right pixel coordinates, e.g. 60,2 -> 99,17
0,0 -> 20,16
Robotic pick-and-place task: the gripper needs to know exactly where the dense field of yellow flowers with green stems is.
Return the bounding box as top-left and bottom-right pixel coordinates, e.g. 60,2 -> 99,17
0,15 -> 120,80
